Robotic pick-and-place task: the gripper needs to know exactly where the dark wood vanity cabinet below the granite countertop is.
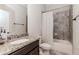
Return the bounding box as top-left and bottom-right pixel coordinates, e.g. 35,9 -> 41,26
9,40 -> 39,55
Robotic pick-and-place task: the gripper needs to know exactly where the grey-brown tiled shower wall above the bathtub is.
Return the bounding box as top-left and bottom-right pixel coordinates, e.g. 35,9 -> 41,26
53,5 -> 71,41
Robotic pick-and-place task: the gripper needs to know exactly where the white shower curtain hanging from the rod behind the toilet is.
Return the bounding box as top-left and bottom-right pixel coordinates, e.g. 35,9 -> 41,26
42,12 -> 53,44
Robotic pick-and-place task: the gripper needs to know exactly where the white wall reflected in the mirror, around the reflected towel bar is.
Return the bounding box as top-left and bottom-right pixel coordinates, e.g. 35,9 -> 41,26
7,4 -> 27,34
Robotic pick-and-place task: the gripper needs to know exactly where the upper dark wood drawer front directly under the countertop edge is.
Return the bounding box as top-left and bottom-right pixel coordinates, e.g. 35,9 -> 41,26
9,40 -> 39,55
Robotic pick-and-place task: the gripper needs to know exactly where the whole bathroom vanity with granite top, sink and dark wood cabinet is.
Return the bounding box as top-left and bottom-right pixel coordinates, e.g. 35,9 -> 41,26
0,37 -> 39,55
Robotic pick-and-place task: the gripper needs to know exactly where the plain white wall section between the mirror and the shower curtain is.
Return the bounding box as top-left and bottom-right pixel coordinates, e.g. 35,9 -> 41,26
27,4 -> 44,37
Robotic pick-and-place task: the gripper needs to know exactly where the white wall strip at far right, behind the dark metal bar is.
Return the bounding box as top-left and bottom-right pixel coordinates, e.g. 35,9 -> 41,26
73,5 -> 79,54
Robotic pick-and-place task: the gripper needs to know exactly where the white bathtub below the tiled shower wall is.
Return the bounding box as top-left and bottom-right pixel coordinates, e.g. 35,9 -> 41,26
51,39 -> 72,55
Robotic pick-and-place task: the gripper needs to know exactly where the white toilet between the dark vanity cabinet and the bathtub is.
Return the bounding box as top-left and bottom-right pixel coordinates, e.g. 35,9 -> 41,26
40,43 -> 51,55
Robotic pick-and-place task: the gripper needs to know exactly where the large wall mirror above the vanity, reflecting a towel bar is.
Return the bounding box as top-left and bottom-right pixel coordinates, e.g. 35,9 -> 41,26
0,4 -> 28,35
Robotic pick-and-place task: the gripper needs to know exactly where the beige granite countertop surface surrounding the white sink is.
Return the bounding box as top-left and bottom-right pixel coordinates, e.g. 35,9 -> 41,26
0,37 -> 38,55
